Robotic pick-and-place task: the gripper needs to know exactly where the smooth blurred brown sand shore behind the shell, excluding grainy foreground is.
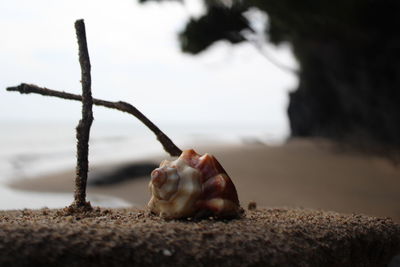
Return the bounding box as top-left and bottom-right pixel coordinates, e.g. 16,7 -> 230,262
10,139 -> 400,222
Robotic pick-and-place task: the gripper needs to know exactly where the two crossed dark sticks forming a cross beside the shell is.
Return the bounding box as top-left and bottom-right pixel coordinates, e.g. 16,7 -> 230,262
6,19 -> 182,212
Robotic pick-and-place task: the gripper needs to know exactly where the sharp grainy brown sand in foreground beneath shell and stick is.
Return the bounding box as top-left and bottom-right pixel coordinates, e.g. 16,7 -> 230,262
0,208 -> 400,267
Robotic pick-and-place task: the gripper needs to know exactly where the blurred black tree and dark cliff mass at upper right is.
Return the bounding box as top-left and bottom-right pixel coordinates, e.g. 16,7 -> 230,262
139,0 -> 400,151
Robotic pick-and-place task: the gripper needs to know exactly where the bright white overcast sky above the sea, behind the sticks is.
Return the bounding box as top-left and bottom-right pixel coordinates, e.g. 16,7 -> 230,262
0,0 -> 297,133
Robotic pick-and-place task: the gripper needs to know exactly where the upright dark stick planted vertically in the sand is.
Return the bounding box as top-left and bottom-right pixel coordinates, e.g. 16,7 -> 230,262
72,19 -> 93,209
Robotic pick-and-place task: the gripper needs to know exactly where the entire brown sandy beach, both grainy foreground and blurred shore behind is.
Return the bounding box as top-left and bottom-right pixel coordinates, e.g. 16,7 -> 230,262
0,139 -> 400,267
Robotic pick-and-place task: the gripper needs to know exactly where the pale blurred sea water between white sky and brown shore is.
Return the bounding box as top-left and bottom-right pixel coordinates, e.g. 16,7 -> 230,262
0,121 -> 287,209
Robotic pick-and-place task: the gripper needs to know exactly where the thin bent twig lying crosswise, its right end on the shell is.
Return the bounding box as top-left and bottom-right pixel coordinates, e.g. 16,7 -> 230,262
6,83 -> 182,157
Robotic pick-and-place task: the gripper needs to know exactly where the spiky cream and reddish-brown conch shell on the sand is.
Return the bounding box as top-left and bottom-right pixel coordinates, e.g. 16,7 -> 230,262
148,149 -> 240,219
